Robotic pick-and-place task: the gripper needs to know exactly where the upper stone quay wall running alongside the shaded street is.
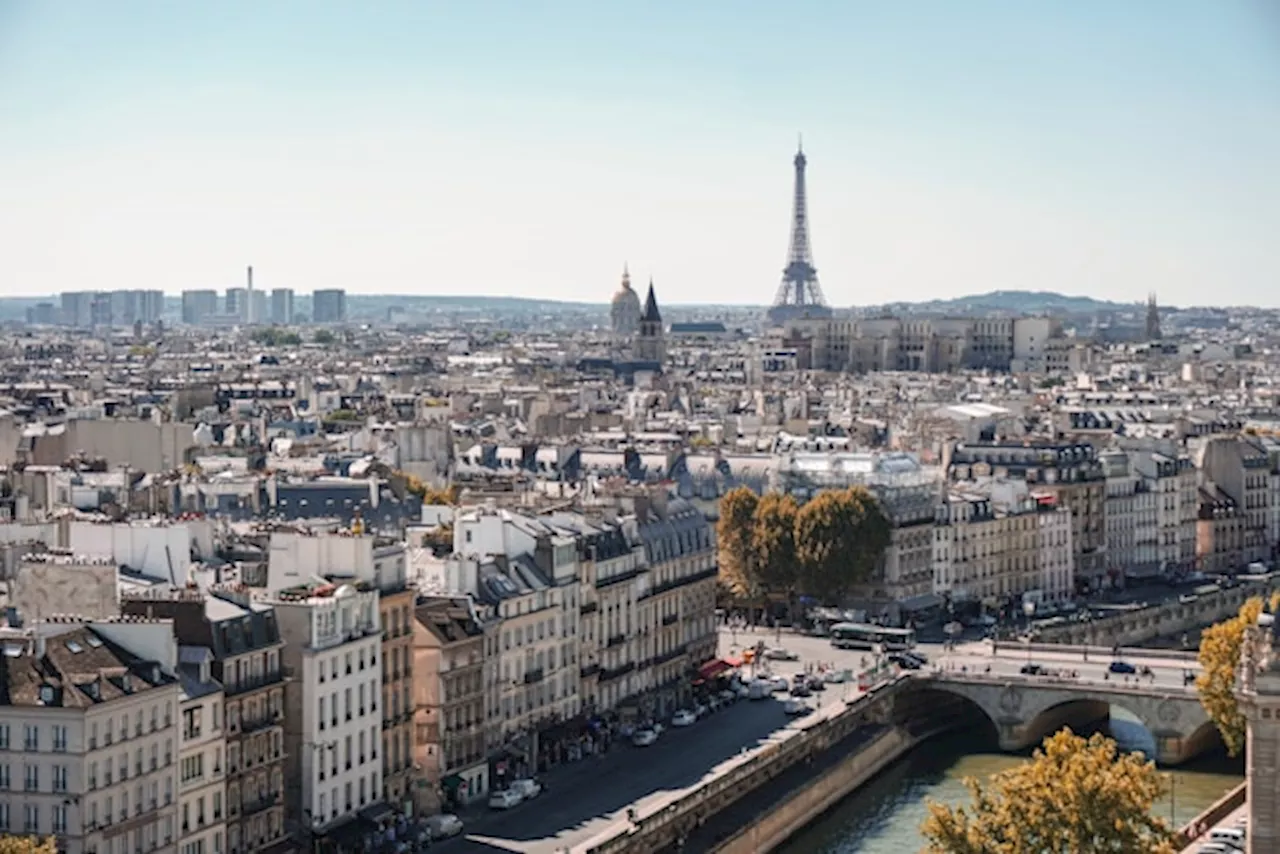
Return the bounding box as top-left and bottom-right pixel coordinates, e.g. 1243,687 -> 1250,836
571,677 -> 908,854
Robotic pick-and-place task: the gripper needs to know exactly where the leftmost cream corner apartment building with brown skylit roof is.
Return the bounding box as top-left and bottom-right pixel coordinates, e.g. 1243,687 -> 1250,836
0,620 -> 180,854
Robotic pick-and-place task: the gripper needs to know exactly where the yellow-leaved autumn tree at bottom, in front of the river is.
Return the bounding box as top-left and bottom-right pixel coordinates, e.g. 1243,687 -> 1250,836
922,730 -> 1175,854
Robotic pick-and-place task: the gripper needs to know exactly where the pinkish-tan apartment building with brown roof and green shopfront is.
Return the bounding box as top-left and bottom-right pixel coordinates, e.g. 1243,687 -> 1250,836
413,597 -> 489,814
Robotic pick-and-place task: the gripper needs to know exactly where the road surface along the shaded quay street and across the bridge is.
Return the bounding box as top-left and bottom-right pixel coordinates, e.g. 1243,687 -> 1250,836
433,629 -> 1187,854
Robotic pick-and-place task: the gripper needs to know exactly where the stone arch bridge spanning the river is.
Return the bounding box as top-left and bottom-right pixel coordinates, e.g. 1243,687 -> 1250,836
897,670 -> 1219,766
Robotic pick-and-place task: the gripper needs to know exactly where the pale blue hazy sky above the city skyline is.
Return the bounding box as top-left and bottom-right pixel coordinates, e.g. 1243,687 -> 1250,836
0,0 -> 1280,307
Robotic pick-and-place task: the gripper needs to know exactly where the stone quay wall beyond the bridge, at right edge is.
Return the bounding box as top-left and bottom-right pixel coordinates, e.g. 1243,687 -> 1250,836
1037,577 -> 1280,649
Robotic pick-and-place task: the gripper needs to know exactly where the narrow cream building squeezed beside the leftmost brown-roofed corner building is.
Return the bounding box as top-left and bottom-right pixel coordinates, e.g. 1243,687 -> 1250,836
178,647 -> 227,854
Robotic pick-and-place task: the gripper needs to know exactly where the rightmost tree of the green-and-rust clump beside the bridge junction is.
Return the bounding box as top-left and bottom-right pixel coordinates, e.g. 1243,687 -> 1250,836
795,487 -> 892,604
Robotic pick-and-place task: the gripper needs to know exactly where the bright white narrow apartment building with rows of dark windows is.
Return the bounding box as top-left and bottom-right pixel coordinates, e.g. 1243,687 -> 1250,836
270,578 -> 384,850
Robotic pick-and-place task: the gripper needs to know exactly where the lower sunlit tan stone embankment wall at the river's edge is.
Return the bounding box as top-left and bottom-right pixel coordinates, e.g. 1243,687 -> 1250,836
712,727 -> 928,854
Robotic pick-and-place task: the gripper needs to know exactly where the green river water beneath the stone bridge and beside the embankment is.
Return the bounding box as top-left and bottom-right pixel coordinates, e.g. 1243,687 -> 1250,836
778,707 -> 1244,854
